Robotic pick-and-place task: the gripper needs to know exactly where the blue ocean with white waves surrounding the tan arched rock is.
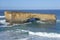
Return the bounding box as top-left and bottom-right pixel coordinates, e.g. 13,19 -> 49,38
0,10 -> 60,40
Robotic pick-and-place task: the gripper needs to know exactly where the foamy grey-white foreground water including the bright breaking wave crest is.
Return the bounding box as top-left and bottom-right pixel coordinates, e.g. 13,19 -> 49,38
0,29 -> 60,40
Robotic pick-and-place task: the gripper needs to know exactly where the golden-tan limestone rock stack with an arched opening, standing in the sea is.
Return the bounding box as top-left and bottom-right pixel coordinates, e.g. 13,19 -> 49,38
5,11 -> 56,23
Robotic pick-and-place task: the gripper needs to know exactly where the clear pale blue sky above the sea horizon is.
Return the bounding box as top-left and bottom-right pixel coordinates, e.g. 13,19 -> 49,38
0,0 -> 60,10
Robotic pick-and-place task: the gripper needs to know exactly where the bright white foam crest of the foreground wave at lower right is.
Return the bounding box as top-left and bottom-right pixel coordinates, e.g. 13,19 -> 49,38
29,31 -> 60,38
